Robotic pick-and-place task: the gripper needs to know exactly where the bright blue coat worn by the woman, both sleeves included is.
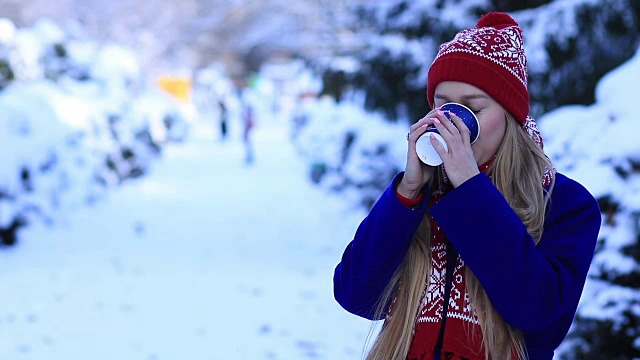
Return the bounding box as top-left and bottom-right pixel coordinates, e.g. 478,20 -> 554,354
333,173 -> 601,360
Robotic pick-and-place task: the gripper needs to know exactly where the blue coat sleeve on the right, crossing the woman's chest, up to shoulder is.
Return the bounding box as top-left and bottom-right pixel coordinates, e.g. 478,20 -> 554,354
431,174 -> 601,333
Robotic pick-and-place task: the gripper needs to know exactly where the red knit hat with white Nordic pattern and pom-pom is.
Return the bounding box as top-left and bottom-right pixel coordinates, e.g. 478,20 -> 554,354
427,12 -> 529,124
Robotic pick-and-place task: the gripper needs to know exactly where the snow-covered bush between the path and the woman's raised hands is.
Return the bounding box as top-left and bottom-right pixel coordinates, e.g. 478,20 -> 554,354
295,96 -> 406,207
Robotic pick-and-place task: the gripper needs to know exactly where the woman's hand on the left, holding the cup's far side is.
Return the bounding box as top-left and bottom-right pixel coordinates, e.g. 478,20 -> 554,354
397,109 -> 437,199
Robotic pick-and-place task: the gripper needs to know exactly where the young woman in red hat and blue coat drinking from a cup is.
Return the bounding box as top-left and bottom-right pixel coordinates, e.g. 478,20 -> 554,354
334,13 -> 601,360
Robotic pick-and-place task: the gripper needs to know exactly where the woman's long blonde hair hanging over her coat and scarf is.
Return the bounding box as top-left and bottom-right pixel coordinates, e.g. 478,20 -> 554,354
366,114 -> 555,360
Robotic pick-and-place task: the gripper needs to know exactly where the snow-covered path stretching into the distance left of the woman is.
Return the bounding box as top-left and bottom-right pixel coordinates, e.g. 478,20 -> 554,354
0,119 -> 369,360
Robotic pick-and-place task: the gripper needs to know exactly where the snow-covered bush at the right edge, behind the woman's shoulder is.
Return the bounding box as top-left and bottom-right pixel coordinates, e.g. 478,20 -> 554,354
540,43 -> 640,360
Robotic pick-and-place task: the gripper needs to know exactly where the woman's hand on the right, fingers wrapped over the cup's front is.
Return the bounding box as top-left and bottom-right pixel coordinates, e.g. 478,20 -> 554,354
431,111 -> 480,187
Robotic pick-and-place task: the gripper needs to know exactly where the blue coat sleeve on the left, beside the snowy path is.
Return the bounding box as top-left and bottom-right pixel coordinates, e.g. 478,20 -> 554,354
333,173 -> 428,320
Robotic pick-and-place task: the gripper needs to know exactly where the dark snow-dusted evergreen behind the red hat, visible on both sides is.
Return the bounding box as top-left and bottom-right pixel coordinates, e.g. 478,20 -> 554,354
318,0 -> 640,122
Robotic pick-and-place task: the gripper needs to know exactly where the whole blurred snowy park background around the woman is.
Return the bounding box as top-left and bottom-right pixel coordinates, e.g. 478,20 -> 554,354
0,0 -> 640,360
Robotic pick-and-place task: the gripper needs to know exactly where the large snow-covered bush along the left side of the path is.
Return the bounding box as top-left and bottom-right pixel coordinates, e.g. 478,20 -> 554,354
0,20 -> 187,244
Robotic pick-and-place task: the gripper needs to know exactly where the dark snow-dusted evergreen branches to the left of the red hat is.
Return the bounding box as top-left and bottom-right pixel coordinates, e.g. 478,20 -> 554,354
319,0 -> 490,121
